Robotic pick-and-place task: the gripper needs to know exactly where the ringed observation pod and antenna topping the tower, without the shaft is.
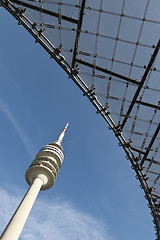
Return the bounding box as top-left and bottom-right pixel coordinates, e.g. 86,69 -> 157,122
25,123 -> 68,190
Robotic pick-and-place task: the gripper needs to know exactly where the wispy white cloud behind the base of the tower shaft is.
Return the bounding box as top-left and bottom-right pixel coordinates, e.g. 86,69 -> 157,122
0,189 -> 113,240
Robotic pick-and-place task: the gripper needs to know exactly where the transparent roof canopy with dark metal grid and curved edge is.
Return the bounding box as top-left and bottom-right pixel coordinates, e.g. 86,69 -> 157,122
0,0 -> 160,239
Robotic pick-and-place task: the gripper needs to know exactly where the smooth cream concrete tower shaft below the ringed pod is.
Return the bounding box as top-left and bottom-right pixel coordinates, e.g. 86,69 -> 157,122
0,177 -> 43,240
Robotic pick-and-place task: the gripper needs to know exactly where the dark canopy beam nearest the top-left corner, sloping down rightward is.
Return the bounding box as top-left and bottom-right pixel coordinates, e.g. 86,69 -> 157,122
11,0 -> 78,24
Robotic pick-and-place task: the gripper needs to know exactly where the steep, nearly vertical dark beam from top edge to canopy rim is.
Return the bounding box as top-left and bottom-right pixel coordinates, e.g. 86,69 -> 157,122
72,0 -> 86,68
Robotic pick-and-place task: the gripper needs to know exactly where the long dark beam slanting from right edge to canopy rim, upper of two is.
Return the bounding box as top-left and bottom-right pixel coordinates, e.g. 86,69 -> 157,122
121,40 -> 160,130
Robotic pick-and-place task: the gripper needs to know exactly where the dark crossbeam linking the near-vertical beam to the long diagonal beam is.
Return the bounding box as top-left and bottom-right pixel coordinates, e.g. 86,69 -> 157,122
76,59 -> 139,85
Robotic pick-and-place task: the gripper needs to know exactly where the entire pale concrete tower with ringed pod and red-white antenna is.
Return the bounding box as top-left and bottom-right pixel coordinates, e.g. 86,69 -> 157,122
0,123 -> 69,240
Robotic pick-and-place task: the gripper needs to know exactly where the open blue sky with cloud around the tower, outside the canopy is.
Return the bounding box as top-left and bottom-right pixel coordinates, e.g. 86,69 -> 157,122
0,5 -> 155,240
